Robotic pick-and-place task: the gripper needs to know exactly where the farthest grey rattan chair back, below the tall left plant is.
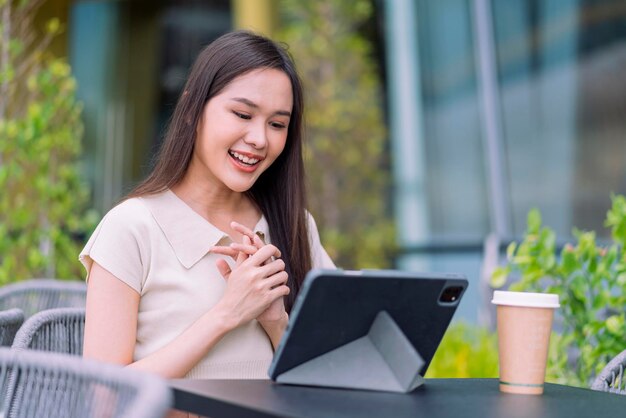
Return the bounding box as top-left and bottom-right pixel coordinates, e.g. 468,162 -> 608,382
0,279 -> 87,318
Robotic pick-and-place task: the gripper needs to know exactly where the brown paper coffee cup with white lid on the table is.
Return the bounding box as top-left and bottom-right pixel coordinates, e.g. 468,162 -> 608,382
491,290 -> 559,395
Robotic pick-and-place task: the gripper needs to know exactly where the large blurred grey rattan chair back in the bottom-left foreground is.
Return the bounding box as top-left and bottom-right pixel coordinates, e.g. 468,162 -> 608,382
0,348 -> 172,418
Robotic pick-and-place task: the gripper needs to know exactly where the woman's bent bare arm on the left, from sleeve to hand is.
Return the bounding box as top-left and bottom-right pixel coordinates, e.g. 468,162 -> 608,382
83,240 -> 289,378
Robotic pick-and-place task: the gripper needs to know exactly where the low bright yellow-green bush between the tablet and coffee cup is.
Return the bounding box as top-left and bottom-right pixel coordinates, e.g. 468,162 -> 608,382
426,322 -> 498,378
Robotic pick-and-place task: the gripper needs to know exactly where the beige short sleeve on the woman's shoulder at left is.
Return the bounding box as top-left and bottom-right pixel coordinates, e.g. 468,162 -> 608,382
78,199 -> 150,294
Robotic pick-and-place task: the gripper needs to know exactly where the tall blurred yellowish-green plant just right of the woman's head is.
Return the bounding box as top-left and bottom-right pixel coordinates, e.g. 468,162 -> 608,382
280,0 -> 395,268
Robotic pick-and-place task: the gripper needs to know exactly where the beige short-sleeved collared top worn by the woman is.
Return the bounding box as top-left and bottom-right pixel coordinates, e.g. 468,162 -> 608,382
79,190 -> 335,379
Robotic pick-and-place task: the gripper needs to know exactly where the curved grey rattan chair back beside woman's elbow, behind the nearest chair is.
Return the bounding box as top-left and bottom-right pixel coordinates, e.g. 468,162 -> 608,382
13,308 -> 85,355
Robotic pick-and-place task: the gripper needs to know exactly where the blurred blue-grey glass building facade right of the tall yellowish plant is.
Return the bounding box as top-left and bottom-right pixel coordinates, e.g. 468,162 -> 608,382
380,0 -> 626,324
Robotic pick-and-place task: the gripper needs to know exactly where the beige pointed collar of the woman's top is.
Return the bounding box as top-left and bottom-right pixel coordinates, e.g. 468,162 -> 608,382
141,190 -> 269,269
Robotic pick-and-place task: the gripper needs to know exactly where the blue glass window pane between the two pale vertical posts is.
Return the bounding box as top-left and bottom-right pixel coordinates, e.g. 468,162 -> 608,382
417,0 -> 489,242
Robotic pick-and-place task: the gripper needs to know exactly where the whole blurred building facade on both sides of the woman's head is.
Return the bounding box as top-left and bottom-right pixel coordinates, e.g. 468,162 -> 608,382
43,0 -> 626,320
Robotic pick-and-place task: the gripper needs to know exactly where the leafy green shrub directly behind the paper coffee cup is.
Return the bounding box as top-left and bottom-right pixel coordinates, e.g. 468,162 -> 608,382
492,195 -> 626,386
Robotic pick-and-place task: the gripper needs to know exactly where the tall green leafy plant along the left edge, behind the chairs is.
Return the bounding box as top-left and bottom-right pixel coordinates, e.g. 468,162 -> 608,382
0,0 -> 96,284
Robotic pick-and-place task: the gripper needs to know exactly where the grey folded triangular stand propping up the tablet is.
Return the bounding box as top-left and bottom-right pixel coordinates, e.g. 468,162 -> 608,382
276,311 -> 424,393
